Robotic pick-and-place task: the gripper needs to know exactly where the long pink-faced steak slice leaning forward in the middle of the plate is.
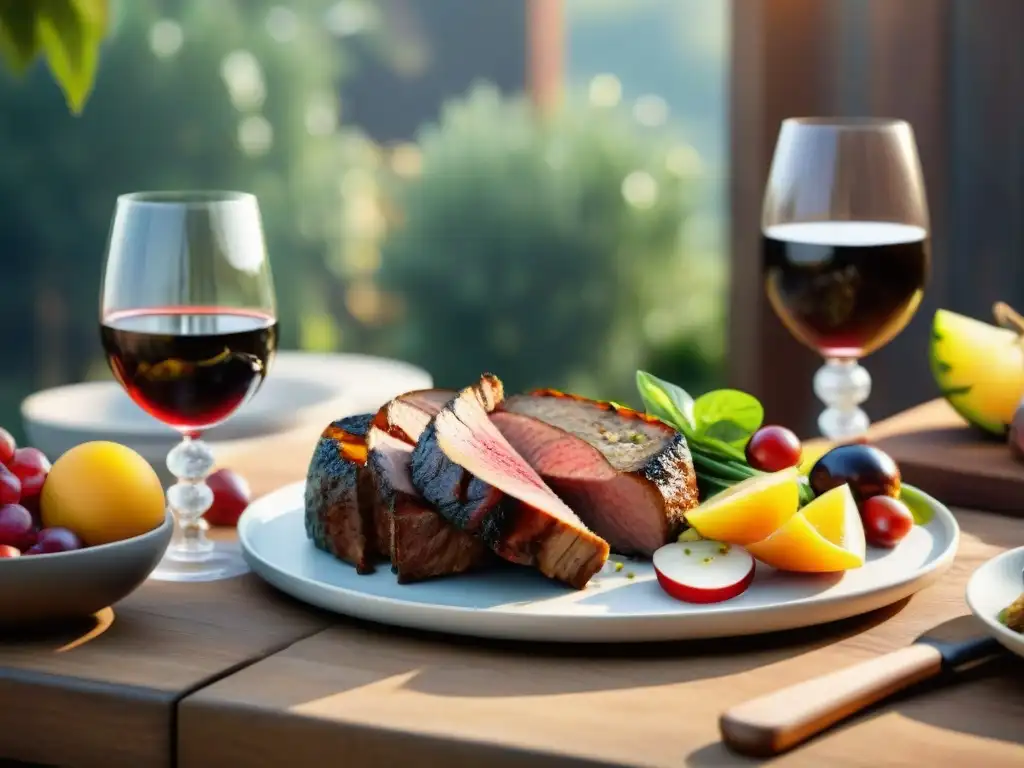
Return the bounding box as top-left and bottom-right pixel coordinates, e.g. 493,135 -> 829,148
412,376 -> 608,589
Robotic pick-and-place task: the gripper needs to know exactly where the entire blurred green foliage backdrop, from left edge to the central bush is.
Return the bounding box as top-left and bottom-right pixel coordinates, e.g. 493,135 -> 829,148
0,0 -> 724,444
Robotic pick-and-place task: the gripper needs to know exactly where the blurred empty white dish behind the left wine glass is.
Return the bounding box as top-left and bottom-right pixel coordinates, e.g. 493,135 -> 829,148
22,351 -> 432,456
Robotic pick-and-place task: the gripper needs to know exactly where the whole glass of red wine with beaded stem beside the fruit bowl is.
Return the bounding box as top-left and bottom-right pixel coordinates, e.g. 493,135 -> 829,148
100,191 -> 278,582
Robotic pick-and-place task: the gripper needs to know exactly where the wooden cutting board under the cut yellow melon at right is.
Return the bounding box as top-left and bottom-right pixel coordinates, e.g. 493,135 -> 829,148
871,399 -> 1024,517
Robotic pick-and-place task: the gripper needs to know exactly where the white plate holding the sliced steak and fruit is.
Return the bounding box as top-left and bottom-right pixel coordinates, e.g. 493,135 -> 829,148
239,482 -> 959,642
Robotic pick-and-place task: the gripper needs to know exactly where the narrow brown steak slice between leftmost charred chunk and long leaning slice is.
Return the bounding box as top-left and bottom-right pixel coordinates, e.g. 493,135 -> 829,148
367,427 -> 489,584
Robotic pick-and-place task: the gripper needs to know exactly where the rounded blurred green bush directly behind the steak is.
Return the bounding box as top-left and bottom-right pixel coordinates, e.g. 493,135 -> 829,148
380,85 -> 721,401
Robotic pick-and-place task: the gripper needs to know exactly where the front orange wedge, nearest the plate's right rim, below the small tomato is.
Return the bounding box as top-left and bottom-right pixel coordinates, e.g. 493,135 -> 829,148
746,485 -> 865,573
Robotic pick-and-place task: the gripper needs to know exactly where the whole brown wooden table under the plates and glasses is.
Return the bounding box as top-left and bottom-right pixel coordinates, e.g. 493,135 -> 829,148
0,405 -> 1024,768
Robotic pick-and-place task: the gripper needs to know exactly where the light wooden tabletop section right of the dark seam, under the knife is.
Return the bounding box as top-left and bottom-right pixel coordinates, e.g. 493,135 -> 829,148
178,510 -> 1024,768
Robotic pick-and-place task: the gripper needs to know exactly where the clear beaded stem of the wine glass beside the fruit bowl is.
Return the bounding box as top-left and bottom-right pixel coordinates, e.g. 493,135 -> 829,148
167,436 -> 214,561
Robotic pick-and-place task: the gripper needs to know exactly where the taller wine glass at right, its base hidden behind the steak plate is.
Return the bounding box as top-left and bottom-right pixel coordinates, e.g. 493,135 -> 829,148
761,118 -> 931,440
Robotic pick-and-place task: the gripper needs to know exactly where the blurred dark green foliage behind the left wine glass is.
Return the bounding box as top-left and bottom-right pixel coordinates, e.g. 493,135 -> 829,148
0,0 -> 380,442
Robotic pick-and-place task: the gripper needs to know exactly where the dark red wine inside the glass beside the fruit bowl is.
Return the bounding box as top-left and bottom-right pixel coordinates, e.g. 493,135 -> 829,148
100,307 -> 278,435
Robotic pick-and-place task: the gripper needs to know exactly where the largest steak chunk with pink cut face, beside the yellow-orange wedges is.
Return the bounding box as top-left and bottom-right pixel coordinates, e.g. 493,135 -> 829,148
492,390 -> 697,556
